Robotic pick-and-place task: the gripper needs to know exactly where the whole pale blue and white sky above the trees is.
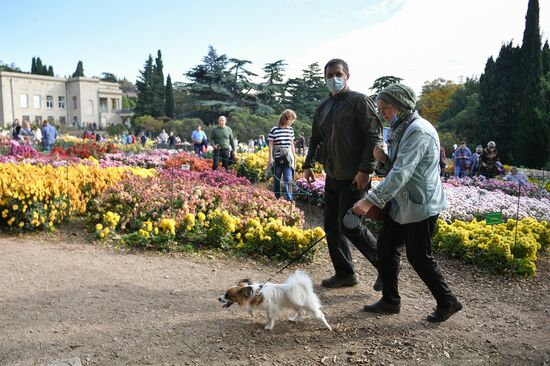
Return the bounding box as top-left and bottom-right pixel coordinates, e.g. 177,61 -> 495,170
0,0 -> 550,93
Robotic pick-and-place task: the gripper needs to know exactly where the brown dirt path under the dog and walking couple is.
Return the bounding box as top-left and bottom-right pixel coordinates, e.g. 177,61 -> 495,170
0,213 -> 550,365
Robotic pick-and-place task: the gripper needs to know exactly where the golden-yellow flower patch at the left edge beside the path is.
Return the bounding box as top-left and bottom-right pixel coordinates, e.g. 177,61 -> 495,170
0,163 -> 156,229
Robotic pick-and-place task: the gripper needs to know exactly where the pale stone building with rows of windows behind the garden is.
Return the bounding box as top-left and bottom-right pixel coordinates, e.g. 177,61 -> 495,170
0,71 -> 132,128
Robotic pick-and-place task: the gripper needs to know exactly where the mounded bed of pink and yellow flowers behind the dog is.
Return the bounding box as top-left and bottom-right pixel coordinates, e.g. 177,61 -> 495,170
89,170 -> 324,259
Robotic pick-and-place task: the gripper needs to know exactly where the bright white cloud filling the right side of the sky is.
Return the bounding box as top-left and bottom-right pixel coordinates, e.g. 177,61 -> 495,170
288,0 -> 550,94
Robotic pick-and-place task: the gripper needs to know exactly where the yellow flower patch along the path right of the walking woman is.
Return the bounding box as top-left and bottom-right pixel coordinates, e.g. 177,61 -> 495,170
434,218 -> 550,275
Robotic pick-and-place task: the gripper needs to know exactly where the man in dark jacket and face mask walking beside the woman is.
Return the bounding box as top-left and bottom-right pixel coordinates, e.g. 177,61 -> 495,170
303,59 -> 382,291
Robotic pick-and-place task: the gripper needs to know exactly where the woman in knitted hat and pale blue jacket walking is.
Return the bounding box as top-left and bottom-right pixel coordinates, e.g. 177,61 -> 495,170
353,84 -> 462,322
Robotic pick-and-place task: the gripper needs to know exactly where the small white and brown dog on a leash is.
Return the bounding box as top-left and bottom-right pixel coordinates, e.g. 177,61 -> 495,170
218,271 -> 332,331
